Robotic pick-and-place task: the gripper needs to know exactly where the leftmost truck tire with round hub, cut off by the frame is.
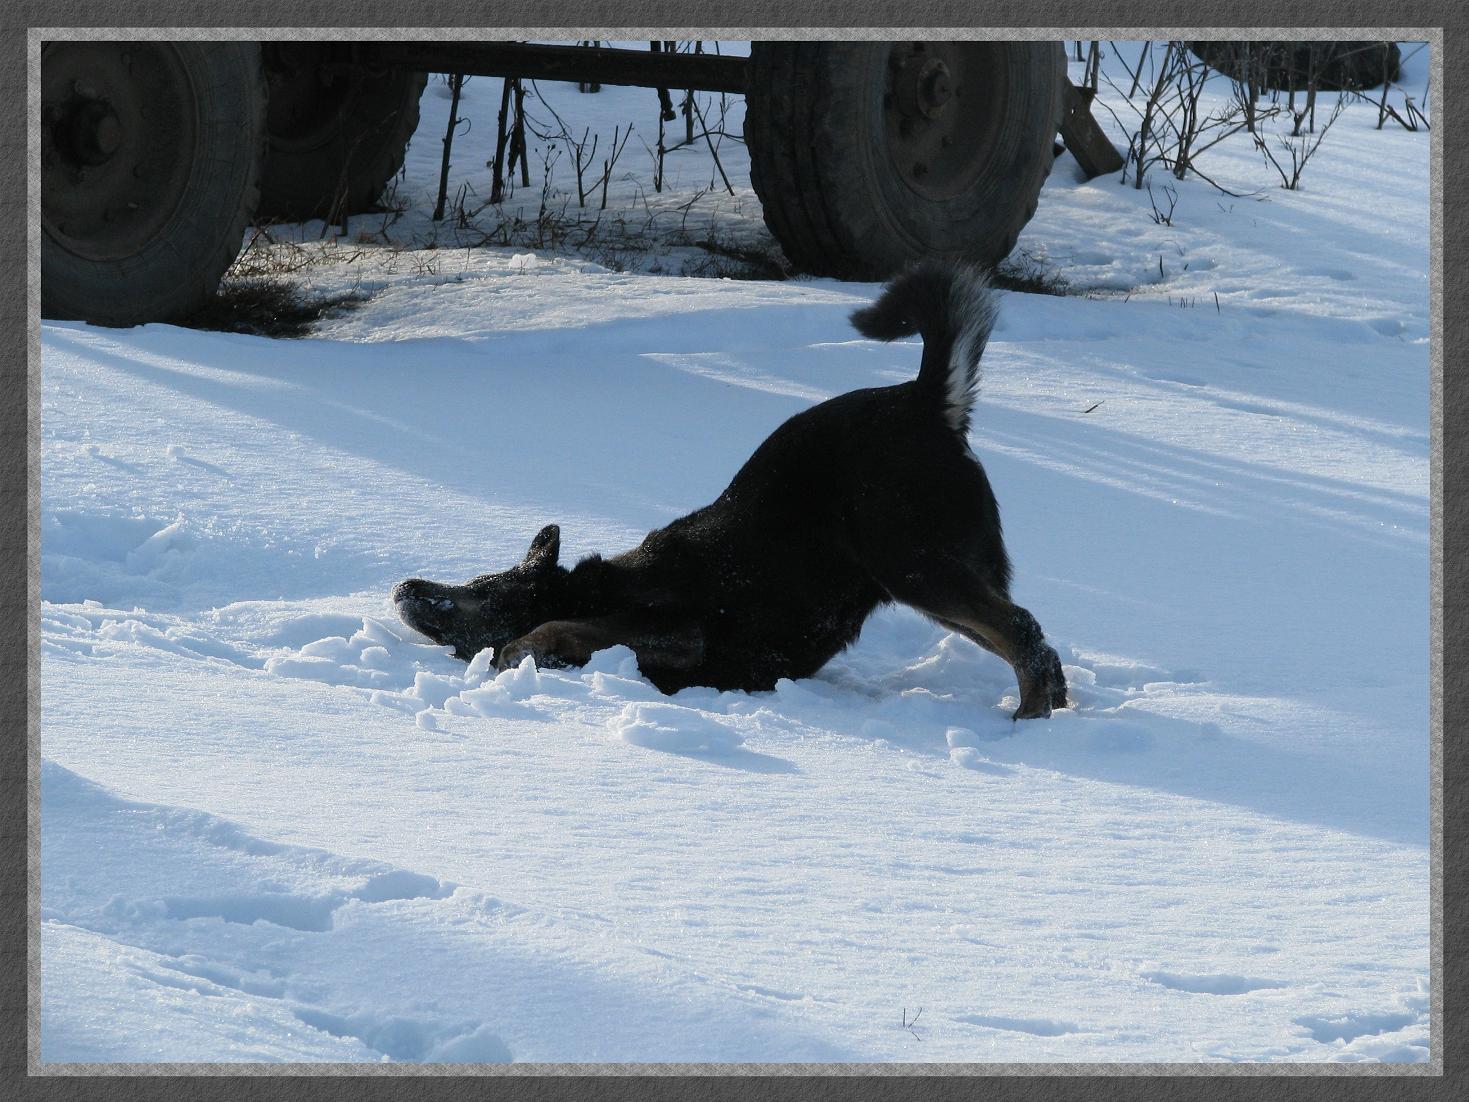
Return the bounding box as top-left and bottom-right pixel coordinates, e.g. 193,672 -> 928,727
41,41 -> 266,326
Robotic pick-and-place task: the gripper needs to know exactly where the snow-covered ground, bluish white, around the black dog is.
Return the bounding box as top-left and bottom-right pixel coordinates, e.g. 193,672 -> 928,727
40,43 -> 1429,1062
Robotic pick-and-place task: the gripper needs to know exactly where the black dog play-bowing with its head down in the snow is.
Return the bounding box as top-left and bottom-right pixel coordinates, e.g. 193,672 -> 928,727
392,264 -> 1066,719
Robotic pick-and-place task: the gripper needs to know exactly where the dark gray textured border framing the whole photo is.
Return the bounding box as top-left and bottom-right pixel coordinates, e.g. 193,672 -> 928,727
0,0 -> 1466,1098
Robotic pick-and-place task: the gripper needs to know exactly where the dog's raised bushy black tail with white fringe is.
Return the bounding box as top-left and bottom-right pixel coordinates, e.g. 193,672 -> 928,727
852,262 -> 995,435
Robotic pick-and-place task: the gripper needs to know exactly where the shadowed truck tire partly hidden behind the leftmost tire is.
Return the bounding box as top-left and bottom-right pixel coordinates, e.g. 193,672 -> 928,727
260,43 -> 427,222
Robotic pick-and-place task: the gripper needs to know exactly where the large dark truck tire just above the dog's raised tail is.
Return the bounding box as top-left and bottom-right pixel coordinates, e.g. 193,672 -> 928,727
745,43 -> 1066,279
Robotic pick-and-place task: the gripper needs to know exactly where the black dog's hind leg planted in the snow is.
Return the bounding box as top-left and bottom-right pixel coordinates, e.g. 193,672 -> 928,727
878,560 -> 1066,720
